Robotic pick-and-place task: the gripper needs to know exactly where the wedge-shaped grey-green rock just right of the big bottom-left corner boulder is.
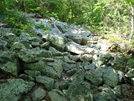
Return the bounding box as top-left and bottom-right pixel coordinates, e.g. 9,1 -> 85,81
36,76 -> 54,90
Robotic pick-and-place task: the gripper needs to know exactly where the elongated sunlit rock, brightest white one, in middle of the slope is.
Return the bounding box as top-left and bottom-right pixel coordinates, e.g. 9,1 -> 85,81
66,42 -> 94,55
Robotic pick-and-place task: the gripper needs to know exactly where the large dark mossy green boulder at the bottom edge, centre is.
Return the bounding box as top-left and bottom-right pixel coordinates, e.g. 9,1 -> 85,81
66,82 -> 93,101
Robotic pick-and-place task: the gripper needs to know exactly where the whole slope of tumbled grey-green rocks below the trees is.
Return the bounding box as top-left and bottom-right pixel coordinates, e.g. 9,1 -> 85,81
0,15 -> 134,101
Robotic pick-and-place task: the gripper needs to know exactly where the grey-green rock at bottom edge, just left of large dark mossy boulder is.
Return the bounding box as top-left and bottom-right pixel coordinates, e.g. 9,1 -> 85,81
48,89 -> 68,101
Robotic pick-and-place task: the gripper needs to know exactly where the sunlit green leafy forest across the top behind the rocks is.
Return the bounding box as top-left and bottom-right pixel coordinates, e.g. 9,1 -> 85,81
0,0 -> 134,41
